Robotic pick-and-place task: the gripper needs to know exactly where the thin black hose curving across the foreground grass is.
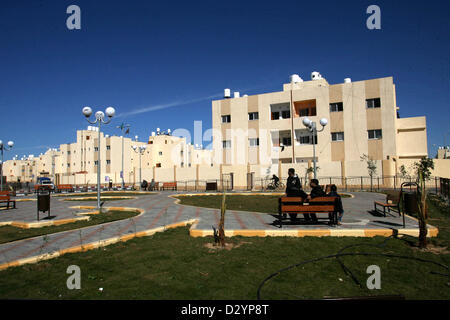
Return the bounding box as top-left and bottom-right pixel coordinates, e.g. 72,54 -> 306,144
257,234 -> 450,300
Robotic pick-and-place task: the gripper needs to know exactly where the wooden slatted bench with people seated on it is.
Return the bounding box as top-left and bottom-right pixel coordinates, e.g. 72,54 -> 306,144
275,197 -> 338,228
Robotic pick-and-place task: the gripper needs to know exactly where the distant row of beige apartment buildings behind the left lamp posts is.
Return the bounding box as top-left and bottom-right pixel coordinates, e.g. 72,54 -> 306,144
4,126 -> 212,185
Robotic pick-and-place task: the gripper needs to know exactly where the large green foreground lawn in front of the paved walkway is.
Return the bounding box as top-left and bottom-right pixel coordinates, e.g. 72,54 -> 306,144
0,196 -> 450,299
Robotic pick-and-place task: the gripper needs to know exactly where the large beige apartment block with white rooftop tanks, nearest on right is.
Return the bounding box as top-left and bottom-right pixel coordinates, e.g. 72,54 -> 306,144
212,72 -> 428,176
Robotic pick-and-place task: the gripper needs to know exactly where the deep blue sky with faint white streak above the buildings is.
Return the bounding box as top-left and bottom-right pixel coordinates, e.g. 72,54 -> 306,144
0,0 -> 450,159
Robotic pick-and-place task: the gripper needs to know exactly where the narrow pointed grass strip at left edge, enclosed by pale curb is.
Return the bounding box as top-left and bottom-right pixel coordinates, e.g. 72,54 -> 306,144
0,211 -> 139,243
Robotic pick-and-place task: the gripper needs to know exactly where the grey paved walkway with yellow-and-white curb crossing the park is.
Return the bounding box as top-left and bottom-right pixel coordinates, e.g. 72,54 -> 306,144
0,192 -> 436,270
